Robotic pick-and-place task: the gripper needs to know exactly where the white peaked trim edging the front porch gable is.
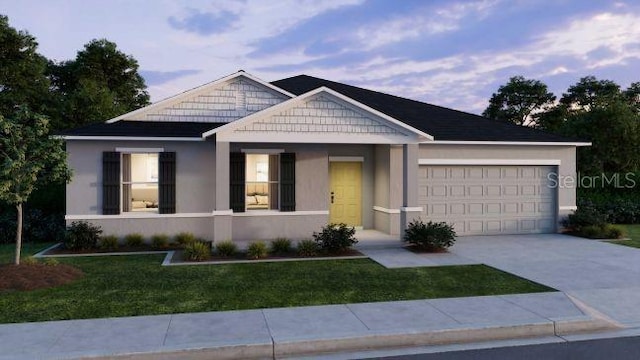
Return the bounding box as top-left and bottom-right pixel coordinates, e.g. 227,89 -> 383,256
202,86 -> 433,142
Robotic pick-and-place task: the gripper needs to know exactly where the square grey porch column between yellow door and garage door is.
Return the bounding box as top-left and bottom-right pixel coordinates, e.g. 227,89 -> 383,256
400,144 -> 422,236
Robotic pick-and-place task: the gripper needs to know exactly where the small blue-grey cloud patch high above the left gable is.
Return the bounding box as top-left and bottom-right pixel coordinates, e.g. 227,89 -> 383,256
167,9 -> 239,35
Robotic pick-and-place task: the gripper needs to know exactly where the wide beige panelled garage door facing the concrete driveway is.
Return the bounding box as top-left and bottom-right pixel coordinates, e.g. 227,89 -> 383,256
418,166 -> 556,235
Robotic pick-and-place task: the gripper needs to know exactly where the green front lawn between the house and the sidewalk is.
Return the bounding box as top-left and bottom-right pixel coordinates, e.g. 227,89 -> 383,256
0,245 -> 552,323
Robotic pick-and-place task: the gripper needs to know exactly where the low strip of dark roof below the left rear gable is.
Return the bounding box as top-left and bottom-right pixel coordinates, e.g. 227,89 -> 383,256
58,120 -> 225,138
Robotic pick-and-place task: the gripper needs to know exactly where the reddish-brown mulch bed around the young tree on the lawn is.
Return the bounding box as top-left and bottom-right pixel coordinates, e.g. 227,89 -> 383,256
0,264 -> 84,291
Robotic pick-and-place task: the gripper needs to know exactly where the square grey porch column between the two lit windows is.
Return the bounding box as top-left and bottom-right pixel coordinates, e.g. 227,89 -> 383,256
213,140 -> 233,242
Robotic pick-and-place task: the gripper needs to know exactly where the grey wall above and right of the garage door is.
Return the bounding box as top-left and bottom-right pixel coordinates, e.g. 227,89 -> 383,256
418,145 -> 577,226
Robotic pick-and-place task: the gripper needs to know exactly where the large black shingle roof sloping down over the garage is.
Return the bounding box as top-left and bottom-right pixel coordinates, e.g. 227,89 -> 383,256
271,75 -> 578,142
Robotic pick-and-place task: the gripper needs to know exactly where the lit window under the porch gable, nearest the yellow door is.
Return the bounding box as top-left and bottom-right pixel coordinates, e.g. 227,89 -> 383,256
245,154 -> 279,210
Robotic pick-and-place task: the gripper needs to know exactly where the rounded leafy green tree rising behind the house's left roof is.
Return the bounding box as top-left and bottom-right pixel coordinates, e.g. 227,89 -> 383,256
49,39 -> 149,128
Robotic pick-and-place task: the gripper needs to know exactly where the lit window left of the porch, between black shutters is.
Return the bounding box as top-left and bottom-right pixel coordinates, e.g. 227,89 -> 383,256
122,153 -> 158,212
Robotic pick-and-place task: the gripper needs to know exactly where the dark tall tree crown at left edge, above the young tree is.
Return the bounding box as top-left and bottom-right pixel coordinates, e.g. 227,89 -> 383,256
0,15 -> 49,116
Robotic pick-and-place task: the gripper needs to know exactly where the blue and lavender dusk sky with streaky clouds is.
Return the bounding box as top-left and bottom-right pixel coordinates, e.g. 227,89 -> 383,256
0,0 -> 640,114
